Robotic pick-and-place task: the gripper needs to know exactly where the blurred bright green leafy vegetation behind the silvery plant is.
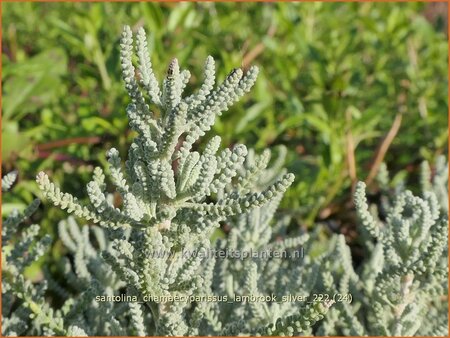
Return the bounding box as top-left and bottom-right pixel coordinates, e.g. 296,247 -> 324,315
1,2 -> 448,232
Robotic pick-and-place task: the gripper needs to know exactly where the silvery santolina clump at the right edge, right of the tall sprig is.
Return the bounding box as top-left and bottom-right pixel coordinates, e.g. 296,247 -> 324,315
318,158 -> 448,336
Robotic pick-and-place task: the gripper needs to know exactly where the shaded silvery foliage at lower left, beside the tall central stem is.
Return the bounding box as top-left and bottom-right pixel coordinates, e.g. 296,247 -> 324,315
2,173 -> 128,336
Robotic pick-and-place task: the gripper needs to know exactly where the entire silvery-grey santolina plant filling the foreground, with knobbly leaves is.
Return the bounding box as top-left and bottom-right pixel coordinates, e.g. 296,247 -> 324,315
2,27 -> 448,336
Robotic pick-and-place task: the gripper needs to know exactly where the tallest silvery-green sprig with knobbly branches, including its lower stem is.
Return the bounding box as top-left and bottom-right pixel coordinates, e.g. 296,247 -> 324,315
37,27 -> 298,335
